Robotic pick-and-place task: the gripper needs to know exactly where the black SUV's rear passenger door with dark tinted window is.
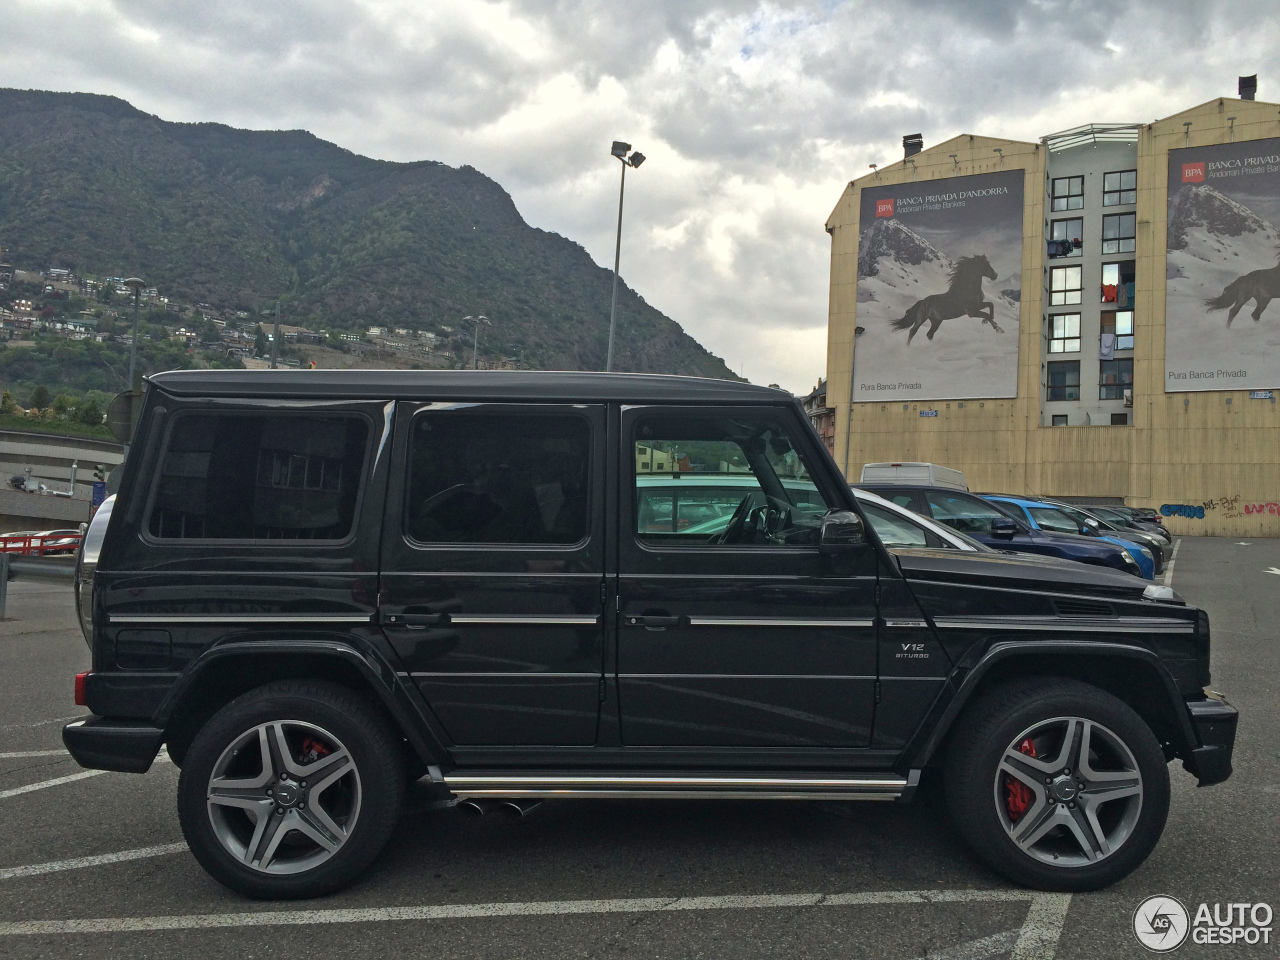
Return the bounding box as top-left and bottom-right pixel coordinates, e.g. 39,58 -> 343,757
379,403 -> 604,746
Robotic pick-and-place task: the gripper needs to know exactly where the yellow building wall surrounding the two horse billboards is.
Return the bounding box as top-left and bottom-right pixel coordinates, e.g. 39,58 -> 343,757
827,99 -> 1280,536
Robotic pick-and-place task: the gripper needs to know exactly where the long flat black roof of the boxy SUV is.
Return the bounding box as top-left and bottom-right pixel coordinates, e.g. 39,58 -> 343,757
147,370 -> 795,404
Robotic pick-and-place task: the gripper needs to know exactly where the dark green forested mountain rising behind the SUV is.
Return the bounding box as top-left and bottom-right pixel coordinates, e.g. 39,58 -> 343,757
0,90 -> 735,379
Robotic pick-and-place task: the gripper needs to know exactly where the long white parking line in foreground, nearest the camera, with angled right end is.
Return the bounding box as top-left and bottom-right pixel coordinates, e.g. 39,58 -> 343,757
0,890 -> 1071,960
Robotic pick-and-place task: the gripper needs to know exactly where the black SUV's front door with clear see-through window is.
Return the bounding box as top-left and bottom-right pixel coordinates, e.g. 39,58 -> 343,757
617,407 -> 877,748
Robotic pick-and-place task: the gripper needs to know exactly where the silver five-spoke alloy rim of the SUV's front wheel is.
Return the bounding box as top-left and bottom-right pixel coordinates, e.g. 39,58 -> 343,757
995,717 -> 1142,867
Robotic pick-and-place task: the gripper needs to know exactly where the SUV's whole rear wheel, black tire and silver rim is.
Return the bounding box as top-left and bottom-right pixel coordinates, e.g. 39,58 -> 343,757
178,680 -> 404,899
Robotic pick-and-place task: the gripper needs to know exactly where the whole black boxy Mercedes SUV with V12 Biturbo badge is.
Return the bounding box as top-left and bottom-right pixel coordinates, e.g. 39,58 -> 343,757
64,371 -> 1236,897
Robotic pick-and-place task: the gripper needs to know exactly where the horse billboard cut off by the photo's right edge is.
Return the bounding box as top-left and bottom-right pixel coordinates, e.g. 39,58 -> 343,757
1165,138 -> 1280,392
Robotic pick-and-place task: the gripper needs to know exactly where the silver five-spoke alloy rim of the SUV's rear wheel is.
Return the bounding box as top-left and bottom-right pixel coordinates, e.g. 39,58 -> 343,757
207,721 -> 361,874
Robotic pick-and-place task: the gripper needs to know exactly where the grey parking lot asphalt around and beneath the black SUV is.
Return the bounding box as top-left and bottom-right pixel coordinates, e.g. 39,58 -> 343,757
0,538 -> 1280,960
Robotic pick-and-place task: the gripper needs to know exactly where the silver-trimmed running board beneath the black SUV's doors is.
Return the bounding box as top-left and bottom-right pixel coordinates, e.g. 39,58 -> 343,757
442,771 -> 920,801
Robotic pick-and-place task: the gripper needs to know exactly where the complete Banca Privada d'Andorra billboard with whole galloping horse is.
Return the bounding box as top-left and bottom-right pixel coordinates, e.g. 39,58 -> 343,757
854,170 -> 1023,403
